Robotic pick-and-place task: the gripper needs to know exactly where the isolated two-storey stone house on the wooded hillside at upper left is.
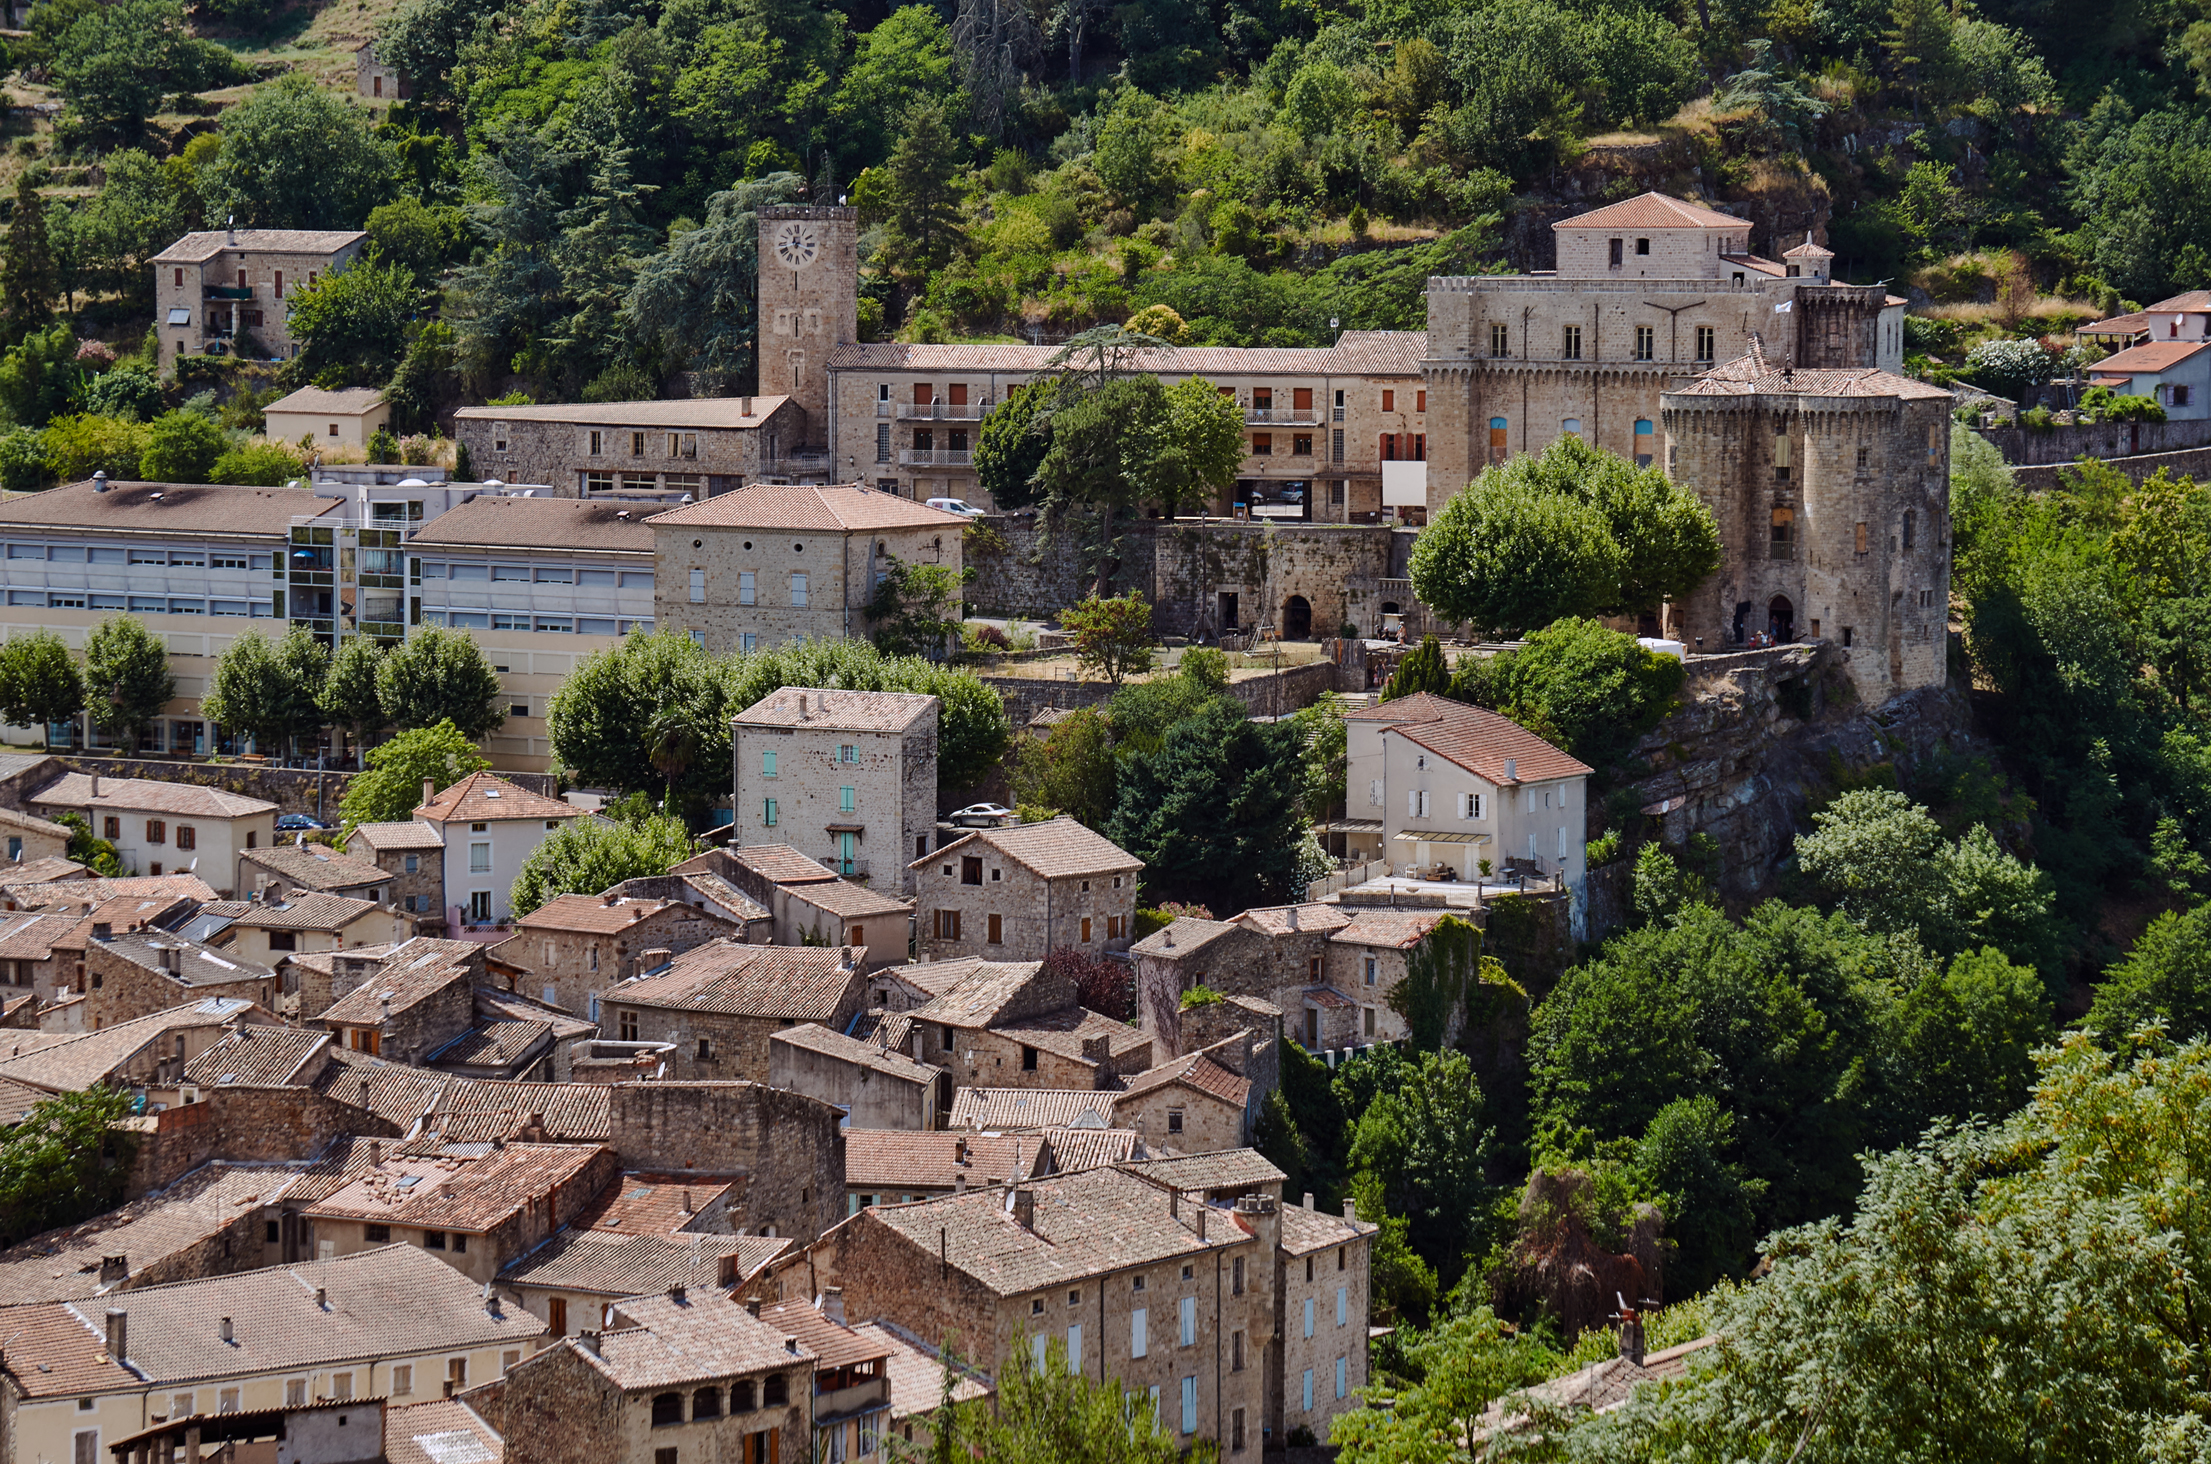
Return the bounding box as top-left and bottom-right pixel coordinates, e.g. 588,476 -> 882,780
150,228 -> 367,372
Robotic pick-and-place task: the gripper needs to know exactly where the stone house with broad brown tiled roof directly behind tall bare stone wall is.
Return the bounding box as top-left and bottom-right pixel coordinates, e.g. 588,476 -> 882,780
599,940 -> 867,1081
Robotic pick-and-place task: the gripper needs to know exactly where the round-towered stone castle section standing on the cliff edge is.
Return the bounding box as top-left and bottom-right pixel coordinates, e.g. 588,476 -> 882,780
1663,347 -> 1955,705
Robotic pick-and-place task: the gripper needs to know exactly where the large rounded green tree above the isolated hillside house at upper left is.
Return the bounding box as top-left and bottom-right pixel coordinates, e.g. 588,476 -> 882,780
201,71 -> 398,231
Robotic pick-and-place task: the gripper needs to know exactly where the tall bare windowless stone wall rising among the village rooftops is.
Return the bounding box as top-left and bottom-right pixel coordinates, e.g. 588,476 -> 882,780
608,1084 -> 845,1241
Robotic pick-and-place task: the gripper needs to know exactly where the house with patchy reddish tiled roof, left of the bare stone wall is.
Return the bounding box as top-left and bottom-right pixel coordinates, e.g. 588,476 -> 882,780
298,1143 -> 621,1285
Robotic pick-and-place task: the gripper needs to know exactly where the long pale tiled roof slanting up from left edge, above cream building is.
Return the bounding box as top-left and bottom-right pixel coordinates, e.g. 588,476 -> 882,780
0,1163 -> 298,1307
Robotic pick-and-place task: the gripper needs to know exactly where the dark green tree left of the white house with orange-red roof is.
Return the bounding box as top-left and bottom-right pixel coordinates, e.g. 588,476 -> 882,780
1106,699 -> 1304,911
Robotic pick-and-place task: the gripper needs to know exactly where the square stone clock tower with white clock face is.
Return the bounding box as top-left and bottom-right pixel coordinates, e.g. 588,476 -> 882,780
758,206 -> 860,449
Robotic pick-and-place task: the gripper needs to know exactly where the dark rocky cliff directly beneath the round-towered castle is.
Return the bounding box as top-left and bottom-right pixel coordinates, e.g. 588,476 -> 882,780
1627,641 -> 1974,902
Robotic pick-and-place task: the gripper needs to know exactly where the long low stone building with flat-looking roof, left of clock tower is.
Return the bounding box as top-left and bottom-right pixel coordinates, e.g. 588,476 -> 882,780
453,394 -> 805,500
